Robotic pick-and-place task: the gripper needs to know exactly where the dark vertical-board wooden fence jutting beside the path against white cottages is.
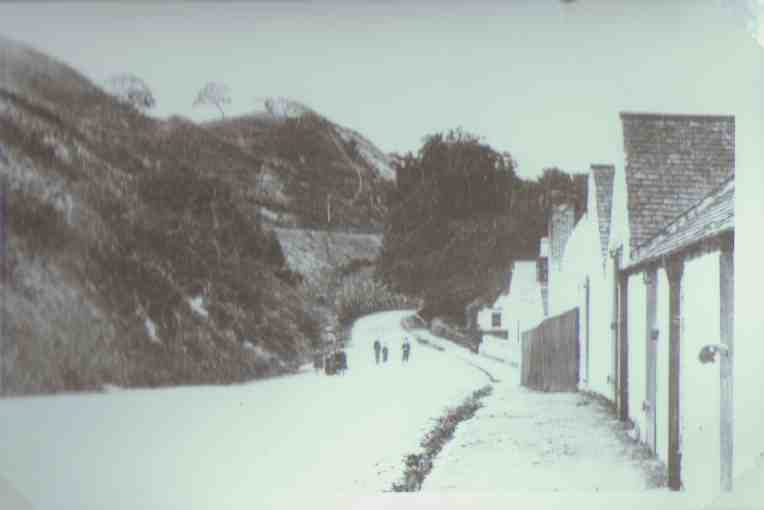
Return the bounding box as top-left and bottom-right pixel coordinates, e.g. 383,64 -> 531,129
521,308 -> 580,391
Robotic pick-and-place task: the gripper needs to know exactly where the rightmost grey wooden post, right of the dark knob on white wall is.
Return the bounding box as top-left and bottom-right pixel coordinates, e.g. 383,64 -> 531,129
719,234 -> 735,492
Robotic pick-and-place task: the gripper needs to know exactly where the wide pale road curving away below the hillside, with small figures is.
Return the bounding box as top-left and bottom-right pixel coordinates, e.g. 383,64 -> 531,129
0,312 -> 488,510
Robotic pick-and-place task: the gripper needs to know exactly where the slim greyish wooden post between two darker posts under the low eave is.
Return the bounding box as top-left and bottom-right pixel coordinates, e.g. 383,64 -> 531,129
643,267 -> 658,453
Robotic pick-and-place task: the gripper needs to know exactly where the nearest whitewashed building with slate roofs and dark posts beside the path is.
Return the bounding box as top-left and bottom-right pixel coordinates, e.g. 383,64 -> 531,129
549,113 -> 764,500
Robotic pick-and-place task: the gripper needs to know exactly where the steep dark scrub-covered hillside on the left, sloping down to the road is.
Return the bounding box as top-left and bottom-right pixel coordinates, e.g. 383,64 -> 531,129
0,39 -> 326,394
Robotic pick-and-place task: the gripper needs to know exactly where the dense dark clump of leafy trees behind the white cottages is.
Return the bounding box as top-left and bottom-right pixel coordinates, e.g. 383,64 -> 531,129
379,129 -> 586,322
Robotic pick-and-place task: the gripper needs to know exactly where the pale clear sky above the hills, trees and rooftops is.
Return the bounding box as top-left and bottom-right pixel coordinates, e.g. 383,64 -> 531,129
0,0 -> 764,177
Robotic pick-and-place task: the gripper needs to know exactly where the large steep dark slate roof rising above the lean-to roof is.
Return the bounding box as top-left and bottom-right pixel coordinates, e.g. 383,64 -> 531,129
621,112 -> 735,256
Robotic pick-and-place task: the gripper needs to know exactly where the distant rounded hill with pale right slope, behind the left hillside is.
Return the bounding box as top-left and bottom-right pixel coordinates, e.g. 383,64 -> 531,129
205,107 -> 394,232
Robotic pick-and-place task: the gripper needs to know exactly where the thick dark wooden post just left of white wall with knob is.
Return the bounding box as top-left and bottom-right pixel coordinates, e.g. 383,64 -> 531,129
666,257 -> 684,491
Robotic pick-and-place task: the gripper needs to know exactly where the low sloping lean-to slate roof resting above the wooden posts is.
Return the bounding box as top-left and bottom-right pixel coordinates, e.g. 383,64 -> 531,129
632,175 -> 735,265
